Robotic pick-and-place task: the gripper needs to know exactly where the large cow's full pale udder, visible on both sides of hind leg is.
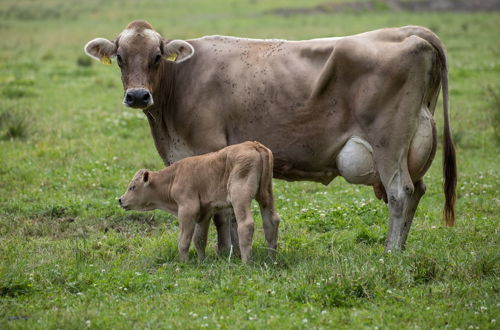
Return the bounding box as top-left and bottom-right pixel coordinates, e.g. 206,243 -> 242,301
336,107 -> 436,185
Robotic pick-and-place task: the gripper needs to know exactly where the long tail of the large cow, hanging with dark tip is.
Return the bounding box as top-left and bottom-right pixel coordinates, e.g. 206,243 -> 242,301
410,27 -> 457,227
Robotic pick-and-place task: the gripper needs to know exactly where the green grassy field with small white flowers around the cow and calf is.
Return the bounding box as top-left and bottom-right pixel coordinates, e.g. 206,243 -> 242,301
0,0 -> 500,329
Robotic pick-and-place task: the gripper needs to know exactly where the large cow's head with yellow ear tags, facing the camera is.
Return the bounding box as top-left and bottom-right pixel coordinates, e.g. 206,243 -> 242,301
84,21 -> 194,109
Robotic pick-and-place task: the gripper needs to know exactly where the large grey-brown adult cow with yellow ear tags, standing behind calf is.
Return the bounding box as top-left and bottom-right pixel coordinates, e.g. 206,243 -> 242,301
84,20 -> 457,251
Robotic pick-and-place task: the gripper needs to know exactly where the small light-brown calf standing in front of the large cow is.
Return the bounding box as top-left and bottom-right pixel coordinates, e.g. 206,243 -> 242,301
118,142 -> 280,262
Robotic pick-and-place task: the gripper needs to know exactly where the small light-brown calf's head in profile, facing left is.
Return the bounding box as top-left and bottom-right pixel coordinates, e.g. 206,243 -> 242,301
118,169 -> 157,211
